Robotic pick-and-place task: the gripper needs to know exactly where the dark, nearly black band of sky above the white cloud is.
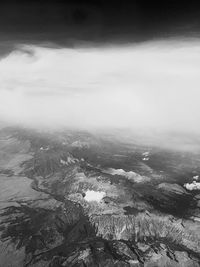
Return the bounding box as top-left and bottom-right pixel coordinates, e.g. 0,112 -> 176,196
0,0 -> 200,46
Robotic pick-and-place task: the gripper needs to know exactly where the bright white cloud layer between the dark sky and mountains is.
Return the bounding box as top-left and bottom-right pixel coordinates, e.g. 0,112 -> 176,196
0,39 -> 200,132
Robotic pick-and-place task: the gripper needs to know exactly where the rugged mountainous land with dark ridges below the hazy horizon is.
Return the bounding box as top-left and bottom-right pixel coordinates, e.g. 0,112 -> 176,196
0,128 -> 200,267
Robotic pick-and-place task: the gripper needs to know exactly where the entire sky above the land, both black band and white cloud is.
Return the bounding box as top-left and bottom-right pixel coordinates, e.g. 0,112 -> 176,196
0,1 -> 200,133
